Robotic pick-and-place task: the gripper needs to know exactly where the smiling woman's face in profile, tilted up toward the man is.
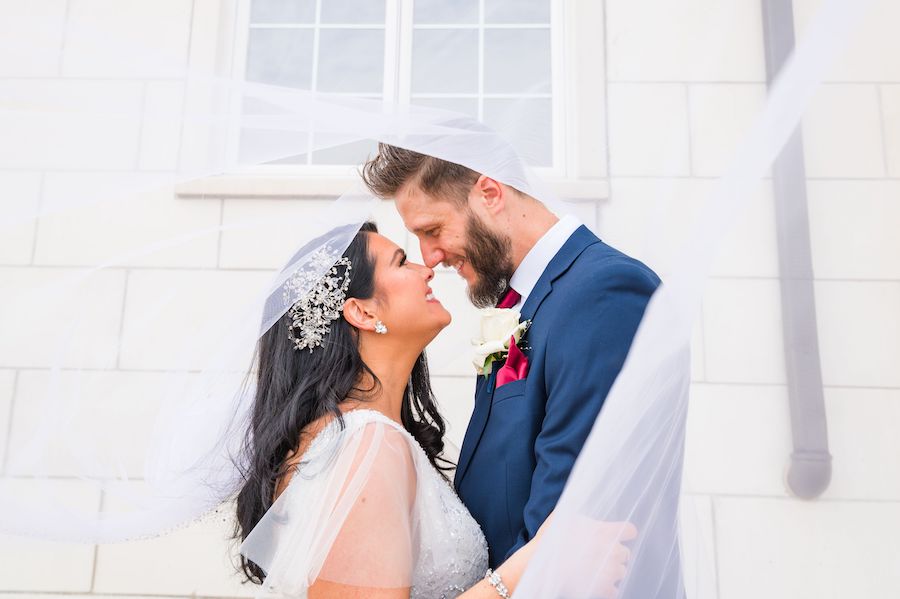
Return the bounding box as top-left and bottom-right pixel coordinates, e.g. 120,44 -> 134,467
369,233 -> 450,347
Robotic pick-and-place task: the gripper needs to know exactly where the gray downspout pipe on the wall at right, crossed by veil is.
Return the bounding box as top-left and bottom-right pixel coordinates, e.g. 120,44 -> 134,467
762,0 -> 831,499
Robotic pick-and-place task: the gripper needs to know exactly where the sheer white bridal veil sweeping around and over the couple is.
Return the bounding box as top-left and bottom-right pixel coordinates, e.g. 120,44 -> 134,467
0,0 -> 866,599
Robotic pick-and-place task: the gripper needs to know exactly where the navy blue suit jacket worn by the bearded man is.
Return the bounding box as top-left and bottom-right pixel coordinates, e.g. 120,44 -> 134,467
455,226 -> 659,568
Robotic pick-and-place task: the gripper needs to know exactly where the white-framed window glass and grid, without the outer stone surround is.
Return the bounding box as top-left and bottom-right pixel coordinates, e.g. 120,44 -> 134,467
235,0 -> 563,174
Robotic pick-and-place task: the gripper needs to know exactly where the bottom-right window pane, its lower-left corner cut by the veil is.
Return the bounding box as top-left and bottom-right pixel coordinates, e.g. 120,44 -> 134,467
483,98 -> 553,166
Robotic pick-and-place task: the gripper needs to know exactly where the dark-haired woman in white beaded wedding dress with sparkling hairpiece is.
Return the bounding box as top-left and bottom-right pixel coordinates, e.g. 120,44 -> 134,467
235,223 -> 629,598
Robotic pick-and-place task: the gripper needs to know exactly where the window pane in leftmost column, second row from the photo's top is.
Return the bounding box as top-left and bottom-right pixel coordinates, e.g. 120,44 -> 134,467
247,29 -> 313,89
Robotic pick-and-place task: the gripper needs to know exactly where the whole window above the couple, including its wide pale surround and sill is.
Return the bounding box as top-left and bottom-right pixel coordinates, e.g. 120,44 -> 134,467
178,0 -> 608,199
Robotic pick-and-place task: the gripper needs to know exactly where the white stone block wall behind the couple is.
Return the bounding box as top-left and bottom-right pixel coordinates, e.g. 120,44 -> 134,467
0,0 -> 900,599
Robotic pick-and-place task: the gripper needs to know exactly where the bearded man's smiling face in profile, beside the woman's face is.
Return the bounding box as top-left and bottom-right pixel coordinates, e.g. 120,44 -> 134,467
395,185 -> 515,307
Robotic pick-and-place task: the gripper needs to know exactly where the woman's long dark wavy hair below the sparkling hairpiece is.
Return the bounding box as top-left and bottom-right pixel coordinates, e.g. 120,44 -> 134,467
234,223 -> 451,584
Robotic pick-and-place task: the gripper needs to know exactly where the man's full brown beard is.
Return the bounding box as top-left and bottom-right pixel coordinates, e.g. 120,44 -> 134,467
465,212 -> 515,308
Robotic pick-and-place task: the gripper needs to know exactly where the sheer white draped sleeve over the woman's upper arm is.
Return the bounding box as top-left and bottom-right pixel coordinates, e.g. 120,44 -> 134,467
241,422 -> 417,597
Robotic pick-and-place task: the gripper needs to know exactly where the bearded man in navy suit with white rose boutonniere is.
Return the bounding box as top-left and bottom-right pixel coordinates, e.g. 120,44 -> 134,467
362,144 -> 659,568
